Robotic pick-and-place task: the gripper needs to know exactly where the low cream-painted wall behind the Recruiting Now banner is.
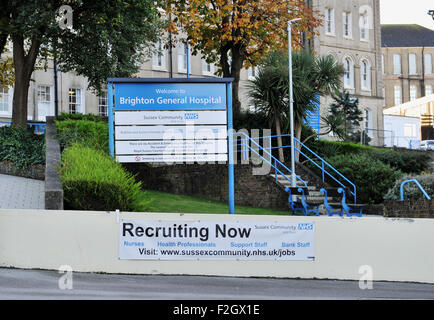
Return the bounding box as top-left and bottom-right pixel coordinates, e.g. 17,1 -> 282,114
0,210 -> 434,283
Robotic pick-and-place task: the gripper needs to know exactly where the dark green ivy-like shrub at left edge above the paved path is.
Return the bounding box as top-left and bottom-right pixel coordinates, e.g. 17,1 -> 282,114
0,127 -> 45,169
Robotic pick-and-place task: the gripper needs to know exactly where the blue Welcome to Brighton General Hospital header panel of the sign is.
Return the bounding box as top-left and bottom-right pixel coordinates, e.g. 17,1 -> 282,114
115,83 -> 227,110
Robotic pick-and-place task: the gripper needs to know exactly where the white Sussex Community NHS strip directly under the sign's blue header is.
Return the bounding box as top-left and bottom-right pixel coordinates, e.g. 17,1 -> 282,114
115,111 -> 227,125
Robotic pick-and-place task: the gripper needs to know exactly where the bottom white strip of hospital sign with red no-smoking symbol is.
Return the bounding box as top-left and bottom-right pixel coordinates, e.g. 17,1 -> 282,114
116,154 -> 228,164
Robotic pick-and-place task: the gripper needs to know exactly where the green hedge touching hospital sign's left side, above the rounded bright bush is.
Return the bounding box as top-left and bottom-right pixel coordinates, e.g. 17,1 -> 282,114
56,120 -> 108,153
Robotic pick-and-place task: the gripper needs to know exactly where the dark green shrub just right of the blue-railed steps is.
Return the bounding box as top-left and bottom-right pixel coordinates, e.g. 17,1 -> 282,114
326,154 -> 402,203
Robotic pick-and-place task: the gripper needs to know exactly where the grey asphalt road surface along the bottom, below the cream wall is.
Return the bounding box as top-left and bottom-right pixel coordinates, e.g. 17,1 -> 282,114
0,268 -> 434,301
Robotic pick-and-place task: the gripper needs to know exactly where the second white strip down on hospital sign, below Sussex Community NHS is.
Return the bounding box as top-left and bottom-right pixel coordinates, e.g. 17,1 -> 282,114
115,126 -> 227,140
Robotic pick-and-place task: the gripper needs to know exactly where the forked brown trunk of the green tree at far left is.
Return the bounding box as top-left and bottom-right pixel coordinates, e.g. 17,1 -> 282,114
12,35 -> 40,128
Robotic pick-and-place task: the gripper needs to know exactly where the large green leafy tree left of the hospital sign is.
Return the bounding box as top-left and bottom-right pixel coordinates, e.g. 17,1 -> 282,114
0,0 -> 162,126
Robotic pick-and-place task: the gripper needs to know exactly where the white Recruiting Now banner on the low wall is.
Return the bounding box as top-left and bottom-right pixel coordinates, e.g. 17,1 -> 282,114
119,220 -> 315,260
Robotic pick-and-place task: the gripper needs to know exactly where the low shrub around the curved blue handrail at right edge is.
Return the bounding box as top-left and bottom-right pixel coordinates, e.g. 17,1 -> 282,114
384,174 -> 434,201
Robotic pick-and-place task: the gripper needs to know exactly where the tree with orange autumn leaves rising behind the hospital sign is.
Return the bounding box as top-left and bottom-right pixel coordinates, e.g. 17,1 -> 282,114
162,0 -> 321,115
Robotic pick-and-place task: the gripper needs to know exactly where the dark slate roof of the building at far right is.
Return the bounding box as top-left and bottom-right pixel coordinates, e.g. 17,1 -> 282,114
381,24 -> 434,47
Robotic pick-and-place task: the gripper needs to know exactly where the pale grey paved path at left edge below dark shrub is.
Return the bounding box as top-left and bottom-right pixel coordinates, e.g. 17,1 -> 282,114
0,174 -> 45,209
